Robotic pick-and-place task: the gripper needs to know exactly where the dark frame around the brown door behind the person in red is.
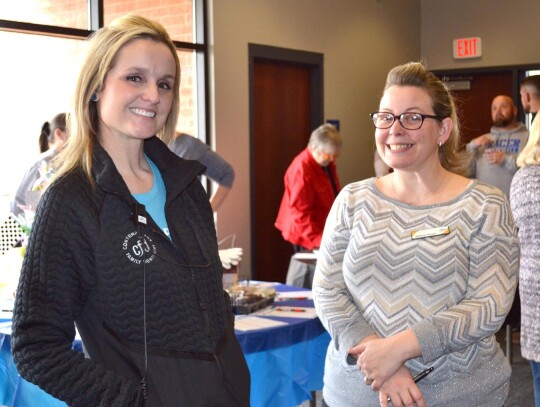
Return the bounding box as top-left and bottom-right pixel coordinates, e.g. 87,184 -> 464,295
248,44 -> 324,277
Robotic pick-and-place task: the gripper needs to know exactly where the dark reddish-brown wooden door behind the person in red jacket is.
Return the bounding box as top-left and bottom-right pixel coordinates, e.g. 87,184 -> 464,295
250,46 -> 322,282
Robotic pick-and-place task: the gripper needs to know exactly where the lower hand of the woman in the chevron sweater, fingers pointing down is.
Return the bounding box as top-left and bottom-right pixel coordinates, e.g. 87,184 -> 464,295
379,366 -> 427,407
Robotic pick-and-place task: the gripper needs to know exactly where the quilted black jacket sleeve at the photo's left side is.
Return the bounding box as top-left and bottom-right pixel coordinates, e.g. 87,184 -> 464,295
11,183 -> 139,407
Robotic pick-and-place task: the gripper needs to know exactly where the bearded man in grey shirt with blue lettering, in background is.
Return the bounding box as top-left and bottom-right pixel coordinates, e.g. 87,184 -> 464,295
467,95 -> 529,196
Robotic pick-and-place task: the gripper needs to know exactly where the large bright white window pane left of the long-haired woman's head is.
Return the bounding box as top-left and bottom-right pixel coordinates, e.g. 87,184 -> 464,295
0,31 -> 84,202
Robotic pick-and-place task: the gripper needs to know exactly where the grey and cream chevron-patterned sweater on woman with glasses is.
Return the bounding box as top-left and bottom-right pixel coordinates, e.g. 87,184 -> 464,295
313,178 -> 519,407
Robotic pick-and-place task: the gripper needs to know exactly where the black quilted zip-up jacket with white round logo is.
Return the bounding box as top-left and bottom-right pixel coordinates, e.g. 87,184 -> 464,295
11,137 -> 250,407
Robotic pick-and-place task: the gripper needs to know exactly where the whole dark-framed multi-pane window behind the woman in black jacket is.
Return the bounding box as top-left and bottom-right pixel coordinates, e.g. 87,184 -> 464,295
0,0 -> 208,214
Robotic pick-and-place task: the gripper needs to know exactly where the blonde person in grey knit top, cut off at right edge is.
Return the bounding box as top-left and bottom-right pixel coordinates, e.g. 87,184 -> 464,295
510,115 -> 540,407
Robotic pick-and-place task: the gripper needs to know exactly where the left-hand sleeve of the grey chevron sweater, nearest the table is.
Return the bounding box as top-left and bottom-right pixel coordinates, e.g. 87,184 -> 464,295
313,187 -> 375,363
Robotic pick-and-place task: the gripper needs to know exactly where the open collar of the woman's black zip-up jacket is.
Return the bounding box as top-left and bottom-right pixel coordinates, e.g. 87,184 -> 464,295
92,136 -> 206,201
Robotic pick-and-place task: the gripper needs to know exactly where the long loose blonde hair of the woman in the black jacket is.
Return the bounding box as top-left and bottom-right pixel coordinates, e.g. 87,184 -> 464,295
57,14 -> 180,185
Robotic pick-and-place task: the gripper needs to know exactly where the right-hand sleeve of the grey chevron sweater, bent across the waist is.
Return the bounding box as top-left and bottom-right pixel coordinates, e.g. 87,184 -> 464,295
411,195 -> 520,363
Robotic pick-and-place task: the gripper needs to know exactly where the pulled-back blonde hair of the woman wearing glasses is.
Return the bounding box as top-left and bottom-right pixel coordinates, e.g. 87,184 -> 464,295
384,62 -> 470,176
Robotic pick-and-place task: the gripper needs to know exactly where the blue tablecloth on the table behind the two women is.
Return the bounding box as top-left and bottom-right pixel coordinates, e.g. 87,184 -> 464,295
0,285 -> 330,407
